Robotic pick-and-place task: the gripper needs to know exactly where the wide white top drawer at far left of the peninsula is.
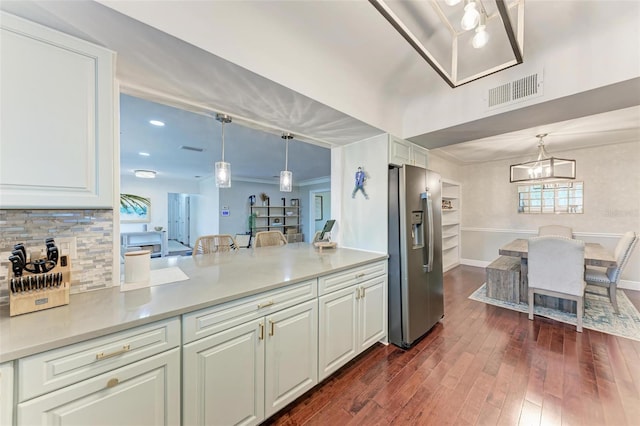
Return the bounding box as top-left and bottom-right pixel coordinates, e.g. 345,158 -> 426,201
18,318 -> 180,402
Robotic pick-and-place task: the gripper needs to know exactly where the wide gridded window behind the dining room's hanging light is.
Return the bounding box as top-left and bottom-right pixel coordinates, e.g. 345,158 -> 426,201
518,182 -> 583,213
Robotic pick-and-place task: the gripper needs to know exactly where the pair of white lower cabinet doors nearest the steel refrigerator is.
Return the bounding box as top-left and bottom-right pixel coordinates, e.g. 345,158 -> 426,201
318,275 -> 387,380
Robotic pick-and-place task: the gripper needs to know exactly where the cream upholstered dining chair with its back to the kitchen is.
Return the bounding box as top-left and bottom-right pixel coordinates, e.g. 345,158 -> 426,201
528,235 -> 586,332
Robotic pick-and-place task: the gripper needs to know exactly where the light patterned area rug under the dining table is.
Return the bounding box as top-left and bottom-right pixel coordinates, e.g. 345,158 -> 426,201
469,283 -> 640,341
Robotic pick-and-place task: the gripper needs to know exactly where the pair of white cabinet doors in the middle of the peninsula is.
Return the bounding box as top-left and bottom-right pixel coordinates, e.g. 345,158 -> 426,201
183,299 -> 318,425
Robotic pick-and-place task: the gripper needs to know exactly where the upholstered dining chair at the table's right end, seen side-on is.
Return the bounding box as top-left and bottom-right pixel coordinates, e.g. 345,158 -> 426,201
584,231 -> 638,314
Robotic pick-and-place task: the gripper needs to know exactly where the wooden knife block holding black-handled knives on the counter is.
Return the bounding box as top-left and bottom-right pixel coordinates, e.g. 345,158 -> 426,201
7,255 -> 71,317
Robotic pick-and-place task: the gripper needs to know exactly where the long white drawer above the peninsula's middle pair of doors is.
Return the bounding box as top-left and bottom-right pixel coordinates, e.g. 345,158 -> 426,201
182,279 -> 318,344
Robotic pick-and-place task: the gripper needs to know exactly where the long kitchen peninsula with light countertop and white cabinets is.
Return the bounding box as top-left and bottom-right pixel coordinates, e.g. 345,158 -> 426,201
0,243 -> 387,424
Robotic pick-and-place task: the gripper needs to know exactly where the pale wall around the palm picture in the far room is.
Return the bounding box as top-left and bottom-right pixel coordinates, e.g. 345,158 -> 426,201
120,176 -> 199,235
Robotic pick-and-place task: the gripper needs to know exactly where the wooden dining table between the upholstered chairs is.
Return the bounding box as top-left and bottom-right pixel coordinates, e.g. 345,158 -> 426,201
498,238 -> 617,313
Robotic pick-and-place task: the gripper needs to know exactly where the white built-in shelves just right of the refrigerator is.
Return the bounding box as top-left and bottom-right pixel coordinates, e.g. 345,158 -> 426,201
442,178 -> 462,272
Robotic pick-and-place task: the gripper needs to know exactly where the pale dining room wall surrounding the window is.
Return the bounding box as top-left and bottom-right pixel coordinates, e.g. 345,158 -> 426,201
462,142 -> 640,284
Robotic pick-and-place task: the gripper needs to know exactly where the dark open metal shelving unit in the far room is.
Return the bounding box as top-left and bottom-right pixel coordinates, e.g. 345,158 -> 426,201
251,198 -> 304,243
